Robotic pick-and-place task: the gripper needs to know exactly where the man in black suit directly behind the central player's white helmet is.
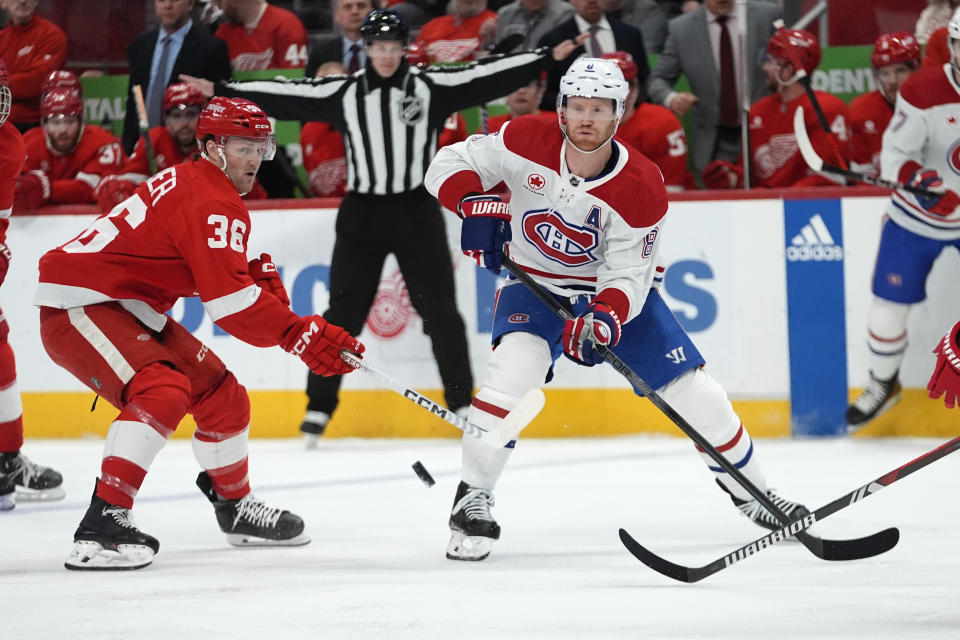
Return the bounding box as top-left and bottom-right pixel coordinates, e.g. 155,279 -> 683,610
537,0 -> 650,111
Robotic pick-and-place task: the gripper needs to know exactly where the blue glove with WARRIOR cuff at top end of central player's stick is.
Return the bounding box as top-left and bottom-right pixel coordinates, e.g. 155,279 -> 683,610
460,195 -> 513,275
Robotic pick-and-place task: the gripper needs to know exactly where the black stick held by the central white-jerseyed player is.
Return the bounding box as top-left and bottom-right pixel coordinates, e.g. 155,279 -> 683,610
503,256 -> 899,560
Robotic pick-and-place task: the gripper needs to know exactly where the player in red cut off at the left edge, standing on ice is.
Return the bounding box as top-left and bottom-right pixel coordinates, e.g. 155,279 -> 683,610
0,60 -> 64,511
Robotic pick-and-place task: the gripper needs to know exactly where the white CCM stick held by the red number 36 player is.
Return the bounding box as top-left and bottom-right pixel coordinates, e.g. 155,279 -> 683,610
340,351 -> 546,448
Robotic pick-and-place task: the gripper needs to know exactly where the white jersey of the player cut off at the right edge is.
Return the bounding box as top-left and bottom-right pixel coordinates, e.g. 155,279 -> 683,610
880,64 -> 960,240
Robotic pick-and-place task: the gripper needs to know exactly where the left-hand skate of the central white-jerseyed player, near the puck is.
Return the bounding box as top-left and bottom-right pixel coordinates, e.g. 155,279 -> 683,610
447,481 -> 500,560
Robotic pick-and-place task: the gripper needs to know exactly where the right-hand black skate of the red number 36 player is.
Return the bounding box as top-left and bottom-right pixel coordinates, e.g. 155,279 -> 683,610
197,471 -> 310,547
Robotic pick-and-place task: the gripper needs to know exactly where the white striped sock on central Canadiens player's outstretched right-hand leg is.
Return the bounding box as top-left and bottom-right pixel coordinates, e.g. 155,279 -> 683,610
657,367 -> 767,500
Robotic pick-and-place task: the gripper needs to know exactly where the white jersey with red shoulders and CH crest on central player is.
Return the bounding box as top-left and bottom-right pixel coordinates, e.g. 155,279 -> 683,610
424,116 -> 667,323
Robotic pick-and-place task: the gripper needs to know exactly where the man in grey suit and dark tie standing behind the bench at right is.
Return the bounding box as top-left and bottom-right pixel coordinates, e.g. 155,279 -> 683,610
647,0 -> 782,173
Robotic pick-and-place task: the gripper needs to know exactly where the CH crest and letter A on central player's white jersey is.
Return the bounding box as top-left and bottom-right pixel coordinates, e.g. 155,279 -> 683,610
521,207 -> 600,267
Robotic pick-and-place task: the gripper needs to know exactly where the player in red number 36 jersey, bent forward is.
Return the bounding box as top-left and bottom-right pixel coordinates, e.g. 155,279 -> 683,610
35,98 -> 363,569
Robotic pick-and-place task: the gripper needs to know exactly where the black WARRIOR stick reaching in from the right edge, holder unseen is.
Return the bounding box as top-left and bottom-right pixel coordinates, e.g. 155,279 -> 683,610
620,437 -> 960,582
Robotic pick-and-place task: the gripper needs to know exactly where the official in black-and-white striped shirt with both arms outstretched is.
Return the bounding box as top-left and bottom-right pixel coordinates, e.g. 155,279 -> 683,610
183,10 -> 582,446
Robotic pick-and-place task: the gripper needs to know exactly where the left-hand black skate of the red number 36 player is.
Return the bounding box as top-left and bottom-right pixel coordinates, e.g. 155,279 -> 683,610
63,494 -> 160,571
